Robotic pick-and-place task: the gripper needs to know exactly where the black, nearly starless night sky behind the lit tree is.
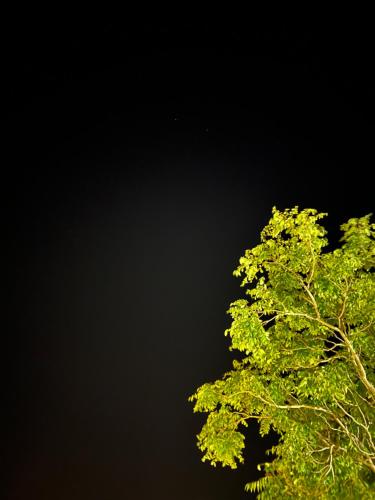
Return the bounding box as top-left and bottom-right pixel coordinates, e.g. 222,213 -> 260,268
1,16 -> 374,500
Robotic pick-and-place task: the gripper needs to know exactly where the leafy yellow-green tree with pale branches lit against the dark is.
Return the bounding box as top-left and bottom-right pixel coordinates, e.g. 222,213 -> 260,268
189,207 -> 375,499
